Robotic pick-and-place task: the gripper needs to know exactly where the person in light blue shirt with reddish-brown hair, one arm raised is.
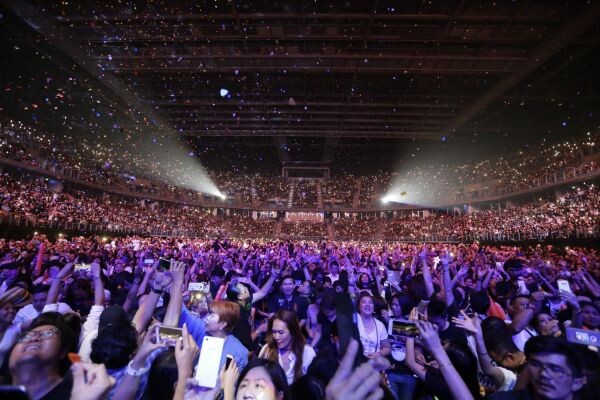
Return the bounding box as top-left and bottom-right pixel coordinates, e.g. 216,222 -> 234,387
163,261 -> 248,370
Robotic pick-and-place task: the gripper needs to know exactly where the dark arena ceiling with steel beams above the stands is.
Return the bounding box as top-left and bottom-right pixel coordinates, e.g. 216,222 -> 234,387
0,0 -> 600,173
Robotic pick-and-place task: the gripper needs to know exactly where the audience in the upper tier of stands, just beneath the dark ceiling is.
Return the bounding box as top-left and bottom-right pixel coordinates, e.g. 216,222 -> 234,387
0,121 -> 600,208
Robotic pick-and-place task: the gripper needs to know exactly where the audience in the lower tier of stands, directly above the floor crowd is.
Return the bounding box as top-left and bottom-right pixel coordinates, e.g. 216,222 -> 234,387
0,173 -> 600,241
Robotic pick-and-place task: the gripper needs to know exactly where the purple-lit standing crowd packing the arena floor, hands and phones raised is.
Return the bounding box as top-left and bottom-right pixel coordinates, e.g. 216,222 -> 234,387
0,234 -> 600,400
